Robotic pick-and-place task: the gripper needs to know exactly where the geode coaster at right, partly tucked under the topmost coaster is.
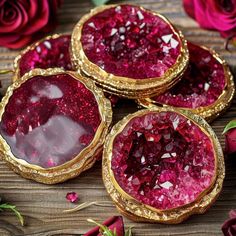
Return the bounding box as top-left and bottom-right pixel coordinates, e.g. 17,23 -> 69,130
139,42 -> 235,121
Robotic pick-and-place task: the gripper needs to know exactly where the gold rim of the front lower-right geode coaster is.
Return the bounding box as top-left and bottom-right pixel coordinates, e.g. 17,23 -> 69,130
102,107 -> 225,224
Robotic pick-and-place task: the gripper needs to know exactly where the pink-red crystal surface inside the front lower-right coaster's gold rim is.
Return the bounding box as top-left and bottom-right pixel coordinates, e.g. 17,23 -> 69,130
111,112 -> 216,210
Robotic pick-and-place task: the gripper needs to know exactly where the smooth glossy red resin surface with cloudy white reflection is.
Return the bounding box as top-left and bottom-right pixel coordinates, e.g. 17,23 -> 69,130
0,74 -> 101,168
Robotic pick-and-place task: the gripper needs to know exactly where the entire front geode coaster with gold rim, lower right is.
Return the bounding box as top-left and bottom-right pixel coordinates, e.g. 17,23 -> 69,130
103,108 -> 225,224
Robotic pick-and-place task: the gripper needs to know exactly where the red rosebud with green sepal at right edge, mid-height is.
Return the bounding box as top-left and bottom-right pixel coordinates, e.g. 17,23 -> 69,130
223,120 -> 236,154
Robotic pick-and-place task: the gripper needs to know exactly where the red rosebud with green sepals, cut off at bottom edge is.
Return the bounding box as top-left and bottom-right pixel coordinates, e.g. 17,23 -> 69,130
84,216 -> 125,236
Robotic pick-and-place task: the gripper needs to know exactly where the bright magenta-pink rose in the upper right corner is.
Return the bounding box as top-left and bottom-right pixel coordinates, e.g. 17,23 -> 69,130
183,0 -> 236,37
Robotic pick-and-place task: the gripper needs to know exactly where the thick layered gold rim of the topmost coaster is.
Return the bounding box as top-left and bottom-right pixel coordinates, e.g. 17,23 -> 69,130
70,4 -> 189,98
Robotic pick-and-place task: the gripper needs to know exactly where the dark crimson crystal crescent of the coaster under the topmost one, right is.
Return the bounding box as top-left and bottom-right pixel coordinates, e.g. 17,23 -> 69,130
153,42 -> 226,108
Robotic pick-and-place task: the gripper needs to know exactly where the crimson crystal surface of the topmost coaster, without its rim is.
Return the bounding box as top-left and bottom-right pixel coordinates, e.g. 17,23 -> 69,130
81,5 -> 181,79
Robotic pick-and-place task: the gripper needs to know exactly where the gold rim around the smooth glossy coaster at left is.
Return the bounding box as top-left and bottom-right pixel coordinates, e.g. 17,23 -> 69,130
0,68 -> 112,184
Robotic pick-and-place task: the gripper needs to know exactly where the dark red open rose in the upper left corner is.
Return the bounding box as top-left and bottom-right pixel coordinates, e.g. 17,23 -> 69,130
0,0 -> 61,48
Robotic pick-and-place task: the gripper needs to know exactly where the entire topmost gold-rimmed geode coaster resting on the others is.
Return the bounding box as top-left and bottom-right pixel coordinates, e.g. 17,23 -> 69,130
71,5 -> 188,98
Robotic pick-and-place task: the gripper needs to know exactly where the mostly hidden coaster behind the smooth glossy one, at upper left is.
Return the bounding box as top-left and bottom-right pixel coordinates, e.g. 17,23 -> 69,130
13,34 -> 119,106
